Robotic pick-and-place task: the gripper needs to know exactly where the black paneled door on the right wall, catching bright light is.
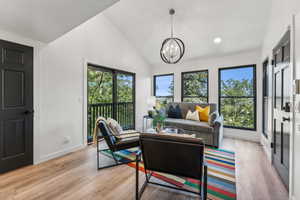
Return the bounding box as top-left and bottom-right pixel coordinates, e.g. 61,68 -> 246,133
272,32 -> 292,188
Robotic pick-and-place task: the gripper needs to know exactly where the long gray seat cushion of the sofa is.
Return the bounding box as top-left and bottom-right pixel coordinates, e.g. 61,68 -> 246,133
165,118 -> 214,132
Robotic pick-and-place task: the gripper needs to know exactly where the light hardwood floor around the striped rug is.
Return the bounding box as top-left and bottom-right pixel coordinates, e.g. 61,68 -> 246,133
0,138 -> 288,200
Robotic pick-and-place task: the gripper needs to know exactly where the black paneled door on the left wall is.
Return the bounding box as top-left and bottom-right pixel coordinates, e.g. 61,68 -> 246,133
0,40 -> 33,173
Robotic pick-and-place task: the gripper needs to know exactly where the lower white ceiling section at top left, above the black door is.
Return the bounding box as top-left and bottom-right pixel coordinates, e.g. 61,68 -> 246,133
0,0 -> 118,42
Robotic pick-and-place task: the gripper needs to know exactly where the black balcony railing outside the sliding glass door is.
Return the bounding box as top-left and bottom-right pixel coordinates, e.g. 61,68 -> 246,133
88,102 -> 135,142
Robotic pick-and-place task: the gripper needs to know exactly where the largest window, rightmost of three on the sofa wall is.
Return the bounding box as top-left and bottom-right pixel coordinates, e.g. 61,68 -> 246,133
219,65 -> 256,130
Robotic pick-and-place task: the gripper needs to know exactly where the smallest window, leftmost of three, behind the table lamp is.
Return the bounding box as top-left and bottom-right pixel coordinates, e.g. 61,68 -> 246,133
154,74 -> 174,107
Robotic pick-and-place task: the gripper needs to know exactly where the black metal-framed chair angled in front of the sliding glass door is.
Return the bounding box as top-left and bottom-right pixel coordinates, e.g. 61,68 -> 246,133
97,121 -> 139,170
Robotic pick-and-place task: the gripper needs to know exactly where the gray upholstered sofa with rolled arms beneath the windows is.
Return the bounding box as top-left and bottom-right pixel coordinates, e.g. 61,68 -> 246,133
165,103 -> 223,147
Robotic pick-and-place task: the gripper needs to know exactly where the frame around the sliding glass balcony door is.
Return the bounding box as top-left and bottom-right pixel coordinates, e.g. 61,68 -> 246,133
82,60 -> 136,146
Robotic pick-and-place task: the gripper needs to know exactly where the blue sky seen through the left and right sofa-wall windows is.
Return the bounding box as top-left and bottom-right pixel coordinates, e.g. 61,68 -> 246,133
156,66 -> 253,96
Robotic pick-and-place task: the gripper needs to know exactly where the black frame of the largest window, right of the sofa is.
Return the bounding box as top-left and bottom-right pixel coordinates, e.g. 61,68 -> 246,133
218,64 -> 257,131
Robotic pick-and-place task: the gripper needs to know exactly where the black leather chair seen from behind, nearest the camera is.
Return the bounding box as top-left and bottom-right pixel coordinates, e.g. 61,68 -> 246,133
136,134 -> 207,199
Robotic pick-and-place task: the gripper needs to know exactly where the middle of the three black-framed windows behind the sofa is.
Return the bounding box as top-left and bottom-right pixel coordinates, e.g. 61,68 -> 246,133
181,70 -> 208,103
